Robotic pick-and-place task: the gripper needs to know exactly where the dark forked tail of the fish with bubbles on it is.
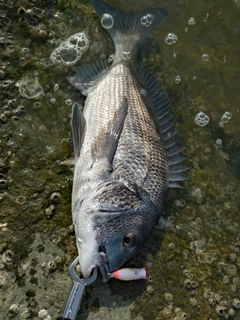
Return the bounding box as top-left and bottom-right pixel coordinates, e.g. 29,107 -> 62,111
91,0 -> 168,62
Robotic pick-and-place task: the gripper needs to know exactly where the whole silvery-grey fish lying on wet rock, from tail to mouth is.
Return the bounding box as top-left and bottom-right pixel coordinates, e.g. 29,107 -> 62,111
68,0 -> 187,282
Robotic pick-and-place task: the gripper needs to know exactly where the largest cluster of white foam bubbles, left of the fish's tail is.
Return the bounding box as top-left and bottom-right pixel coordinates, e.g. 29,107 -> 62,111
50,32 -> 89,66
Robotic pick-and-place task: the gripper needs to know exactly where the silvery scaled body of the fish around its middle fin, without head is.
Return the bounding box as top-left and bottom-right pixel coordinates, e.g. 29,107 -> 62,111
75,64 -> 168,208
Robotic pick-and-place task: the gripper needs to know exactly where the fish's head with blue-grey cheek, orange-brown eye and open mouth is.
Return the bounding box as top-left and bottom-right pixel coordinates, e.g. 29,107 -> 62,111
75,183 -> 157,282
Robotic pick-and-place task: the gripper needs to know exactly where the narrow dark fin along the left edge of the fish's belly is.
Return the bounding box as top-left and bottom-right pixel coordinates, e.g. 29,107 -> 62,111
71,103 -> 86,159
